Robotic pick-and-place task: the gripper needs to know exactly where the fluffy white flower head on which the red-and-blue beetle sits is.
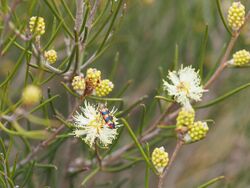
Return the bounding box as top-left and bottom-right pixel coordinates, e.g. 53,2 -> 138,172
73,102 -> 121,148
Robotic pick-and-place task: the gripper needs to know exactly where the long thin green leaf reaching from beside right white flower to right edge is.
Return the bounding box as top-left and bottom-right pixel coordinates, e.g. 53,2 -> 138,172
194,83 -> 250,109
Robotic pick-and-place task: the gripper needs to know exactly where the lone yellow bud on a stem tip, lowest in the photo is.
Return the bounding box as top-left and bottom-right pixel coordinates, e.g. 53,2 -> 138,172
152,147 -> 169,173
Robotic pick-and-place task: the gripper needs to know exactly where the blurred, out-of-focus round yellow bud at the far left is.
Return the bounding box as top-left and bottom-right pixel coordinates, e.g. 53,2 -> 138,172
22,85 -> 42,106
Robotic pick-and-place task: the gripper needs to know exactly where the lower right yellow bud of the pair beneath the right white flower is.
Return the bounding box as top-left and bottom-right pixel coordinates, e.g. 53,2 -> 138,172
184,121 -> 209,143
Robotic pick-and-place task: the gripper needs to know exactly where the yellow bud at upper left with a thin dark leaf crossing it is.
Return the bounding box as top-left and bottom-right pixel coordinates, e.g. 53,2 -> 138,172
29,16 -> 45,36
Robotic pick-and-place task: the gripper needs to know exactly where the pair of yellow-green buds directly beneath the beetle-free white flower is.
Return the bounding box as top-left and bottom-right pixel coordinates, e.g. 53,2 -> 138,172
176,108 -> 209,143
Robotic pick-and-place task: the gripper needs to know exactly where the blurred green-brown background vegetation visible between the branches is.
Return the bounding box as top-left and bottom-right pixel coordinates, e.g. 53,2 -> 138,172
0,0 -> 250,188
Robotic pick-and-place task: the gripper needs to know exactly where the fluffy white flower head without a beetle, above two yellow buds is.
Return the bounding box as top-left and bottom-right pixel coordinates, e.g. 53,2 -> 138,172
163,65 -> 206,109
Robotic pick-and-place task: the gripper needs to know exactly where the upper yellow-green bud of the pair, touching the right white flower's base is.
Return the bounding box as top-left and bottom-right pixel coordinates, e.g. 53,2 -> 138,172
176,108 -> 195,128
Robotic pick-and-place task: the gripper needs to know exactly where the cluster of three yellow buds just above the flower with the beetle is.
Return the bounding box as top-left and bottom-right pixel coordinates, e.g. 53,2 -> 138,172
72,68 -> 114,97
